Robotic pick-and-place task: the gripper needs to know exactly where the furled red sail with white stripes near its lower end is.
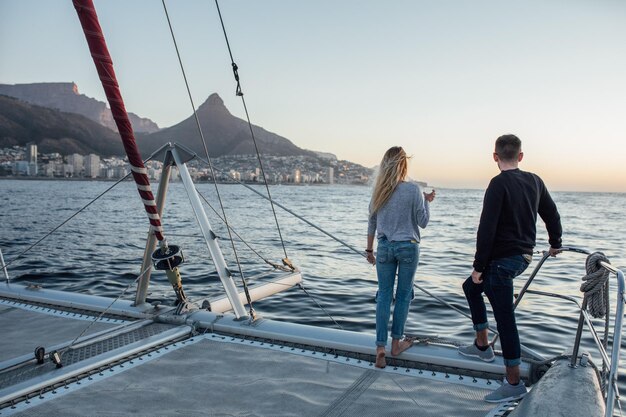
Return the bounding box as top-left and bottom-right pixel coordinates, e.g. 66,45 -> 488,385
74,0 -> 163,241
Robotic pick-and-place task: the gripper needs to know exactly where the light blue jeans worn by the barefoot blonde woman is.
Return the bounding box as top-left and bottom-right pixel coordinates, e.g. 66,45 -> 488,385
376,238 -> 419,346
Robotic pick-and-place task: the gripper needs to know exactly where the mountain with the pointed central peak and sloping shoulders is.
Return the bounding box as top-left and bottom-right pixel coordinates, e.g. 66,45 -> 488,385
137,93 -> 316,157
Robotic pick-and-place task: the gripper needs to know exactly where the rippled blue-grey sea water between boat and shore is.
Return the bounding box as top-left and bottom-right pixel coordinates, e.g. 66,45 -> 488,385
0,180 -> 626,402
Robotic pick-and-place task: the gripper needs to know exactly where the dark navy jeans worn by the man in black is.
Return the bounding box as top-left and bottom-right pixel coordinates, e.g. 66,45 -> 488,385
463,255 -> 528,366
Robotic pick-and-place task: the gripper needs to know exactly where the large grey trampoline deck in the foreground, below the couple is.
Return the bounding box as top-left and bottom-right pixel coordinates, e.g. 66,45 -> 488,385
11,335 -> 502,417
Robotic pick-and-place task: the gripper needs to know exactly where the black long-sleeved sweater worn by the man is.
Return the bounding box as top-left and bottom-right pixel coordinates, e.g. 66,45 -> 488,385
474,169 -> 562,272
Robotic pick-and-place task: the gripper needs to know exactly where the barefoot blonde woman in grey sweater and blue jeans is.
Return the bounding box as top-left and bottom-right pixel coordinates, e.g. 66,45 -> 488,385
365,146 -> 435,368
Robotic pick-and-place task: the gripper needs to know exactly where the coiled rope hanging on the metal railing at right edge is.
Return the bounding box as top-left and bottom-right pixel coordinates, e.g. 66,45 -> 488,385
580,252 -> 610,319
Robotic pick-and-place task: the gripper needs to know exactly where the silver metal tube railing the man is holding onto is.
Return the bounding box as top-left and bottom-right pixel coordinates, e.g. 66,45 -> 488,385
500,247 -> 626,417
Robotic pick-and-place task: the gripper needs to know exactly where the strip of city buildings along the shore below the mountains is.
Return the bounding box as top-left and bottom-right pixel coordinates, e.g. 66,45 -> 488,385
0,143 -> 372,185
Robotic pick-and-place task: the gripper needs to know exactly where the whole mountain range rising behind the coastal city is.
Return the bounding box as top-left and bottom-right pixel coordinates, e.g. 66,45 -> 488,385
0,83 -> 336,160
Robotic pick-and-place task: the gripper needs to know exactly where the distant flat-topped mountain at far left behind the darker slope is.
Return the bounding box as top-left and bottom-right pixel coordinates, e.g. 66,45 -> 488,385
0,83 -> 159,133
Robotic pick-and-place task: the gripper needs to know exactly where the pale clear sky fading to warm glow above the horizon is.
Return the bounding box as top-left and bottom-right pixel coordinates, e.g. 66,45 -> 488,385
0,0 -> 626,192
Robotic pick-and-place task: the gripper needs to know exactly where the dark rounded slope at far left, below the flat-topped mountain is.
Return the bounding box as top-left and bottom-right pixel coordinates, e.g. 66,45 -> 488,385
0,95 -> 124,156
